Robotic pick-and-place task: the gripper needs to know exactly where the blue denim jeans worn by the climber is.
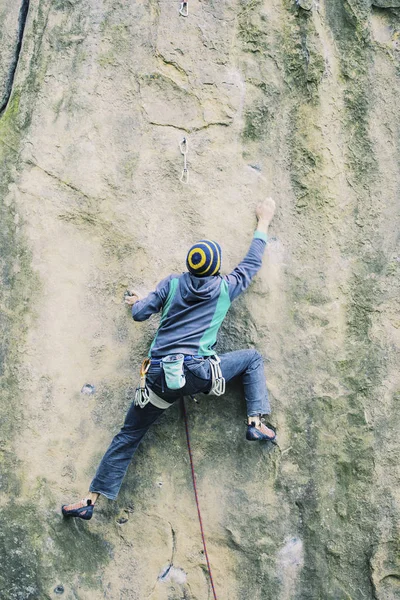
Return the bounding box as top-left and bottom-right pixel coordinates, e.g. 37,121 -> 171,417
89,350 -> 270,500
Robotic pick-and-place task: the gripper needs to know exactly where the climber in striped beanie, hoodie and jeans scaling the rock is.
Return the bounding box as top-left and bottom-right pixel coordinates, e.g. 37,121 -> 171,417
62,198 -> 275,520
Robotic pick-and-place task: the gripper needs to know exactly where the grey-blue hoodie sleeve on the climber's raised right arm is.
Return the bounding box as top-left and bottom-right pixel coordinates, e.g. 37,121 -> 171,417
224,231 -> 267,301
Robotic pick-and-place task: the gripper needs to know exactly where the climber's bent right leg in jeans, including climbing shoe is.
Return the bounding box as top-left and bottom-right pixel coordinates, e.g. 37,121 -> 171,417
220,350 -> 275,439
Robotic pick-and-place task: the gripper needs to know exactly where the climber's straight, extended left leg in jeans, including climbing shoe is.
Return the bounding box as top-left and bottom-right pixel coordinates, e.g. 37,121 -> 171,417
62,403 -> 164,519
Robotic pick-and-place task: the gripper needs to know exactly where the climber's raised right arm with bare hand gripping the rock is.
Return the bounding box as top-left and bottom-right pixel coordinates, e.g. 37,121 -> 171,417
225,198 -> 275,300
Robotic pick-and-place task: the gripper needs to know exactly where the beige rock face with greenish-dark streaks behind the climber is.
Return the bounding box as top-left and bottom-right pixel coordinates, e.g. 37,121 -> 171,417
0,0 -> 400,600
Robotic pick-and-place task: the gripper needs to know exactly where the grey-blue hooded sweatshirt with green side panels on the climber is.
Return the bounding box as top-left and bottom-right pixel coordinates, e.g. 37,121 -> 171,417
132,231 -> 267,358
